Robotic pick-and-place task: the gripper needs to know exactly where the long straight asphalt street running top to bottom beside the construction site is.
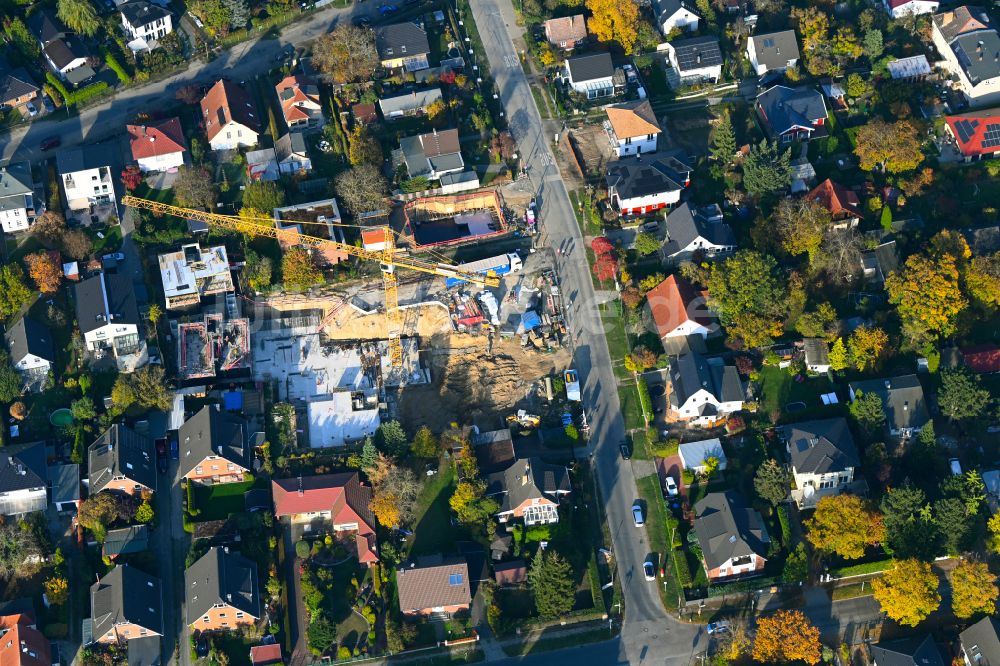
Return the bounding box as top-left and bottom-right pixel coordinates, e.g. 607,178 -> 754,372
471,0 -> 707,664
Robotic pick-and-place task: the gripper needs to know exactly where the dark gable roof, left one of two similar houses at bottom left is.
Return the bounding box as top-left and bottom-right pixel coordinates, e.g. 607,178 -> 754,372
90,564 -> 163,638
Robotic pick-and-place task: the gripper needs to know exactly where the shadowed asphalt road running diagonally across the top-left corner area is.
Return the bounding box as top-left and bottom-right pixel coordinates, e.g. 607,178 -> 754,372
0,2 -> 378,161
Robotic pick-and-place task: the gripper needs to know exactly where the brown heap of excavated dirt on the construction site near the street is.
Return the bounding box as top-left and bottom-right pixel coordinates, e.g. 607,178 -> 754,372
399,336 -> 570,431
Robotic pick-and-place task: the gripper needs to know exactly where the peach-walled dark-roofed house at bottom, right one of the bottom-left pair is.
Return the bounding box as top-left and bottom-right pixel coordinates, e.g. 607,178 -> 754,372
184,546 -> 262,631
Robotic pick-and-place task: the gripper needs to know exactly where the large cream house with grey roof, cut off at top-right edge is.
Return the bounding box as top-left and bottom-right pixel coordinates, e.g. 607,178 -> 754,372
931,2 -> 1000,106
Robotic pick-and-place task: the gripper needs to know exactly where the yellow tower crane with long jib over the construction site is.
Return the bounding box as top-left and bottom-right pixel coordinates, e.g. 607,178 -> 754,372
122,196 -> 500,367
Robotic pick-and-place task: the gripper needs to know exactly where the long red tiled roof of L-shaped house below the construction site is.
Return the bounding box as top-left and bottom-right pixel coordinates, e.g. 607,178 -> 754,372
271,472 -> 375,534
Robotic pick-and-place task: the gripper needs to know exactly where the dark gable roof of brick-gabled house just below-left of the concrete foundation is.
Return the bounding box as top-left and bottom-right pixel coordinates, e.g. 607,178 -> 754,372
178,405 -> 250,475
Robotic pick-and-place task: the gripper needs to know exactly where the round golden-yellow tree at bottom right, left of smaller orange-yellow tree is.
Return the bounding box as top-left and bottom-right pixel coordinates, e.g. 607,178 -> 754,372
872,559 -> 941,627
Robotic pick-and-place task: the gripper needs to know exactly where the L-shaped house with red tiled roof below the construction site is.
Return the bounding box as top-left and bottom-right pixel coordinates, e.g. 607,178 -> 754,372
271,472 -> 378,564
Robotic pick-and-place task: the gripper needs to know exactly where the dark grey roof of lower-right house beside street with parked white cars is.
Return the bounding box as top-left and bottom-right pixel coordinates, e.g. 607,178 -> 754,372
694,490 -> 771,569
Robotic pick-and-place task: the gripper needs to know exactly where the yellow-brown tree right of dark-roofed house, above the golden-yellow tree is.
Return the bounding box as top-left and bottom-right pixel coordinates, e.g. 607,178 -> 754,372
805,495 -> 885,560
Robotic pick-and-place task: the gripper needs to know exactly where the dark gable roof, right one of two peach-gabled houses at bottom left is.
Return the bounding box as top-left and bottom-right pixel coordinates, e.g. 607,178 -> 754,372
184,546 -> 261,624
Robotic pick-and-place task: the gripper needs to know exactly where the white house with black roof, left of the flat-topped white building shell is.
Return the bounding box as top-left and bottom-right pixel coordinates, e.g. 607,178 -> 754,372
73,273 -> 145,359
